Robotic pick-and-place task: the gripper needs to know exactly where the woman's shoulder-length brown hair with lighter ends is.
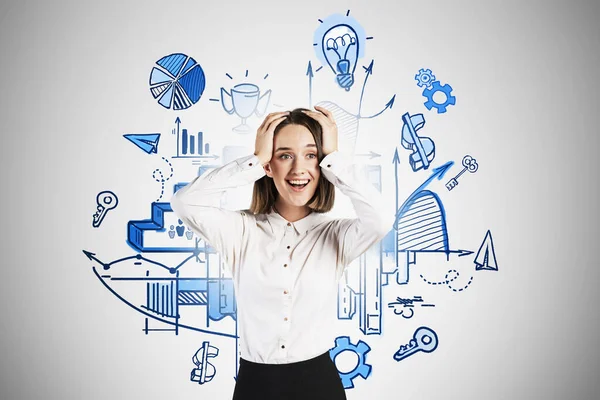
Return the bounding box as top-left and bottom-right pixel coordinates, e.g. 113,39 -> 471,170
250,108 -> 335,214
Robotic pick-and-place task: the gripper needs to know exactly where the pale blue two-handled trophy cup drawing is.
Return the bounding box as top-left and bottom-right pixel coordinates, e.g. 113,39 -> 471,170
221,83 -> 271,133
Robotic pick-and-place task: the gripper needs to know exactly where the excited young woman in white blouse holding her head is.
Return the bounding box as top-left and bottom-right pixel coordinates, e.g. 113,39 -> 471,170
171,107 -> 394,400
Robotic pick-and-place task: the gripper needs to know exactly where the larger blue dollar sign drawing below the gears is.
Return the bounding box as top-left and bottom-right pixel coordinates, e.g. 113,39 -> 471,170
401,113 -> 435,172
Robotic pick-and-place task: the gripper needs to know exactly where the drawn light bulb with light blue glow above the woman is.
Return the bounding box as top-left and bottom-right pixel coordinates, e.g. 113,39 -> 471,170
313,11 -> 372,91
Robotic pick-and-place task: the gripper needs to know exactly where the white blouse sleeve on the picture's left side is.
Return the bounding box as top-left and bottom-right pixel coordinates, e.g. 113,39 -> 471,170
171,155 -> 265,274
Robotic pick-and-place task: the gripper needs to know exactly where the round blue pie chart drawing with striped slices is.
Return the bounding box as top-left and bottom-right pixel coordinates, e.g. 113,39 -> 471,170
150,53 -> 206,110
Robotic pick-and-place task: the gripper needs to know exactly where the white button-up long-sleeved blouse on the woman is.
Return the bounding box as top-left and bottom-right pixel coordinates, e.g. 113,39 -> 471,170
171,151 -> 394,364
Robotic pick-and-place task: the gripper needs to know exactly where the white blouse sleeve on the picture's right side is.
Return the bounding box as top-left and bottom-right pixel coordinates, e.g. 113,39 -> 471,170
319,151 -> 394,267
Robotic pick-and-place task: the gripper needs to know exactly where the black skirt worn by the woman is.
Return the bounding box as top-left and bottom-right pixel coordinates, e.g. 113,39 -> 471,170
233,352 -> 346,400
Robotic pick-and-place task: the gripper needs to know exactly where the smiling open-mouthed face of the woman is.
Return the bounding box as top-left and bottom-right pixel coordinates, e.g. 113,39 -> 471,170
265,124 -> 321,211
